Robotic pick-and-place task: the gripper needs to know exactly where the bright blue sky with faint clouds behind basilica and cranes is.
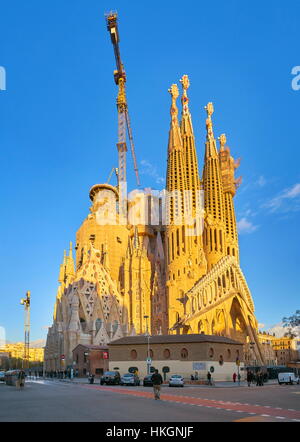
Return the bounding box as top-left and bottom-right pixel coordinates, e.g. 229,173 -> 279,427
0,0 -> 300,341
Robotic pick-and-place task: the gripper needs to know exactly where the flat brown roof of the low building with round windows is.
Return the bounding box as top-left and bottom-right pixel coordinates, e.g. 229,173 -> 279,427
108,334 -> 243,346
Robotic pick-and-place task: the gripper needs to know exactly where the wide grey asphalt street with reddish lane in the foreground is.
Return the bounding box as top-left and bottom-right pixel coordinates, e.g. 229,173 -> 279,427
0,380 -> 300,423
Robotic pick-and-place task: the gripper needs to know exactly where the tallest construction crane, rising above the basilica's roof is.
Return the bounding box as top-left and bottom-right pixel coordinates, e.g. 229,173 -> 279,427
105,12 -> 140,186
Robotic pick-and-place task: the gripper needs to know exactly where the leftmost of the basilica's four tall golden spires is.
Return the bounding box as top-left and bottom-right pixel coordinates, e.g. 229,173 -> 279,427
166,84 -> 187,329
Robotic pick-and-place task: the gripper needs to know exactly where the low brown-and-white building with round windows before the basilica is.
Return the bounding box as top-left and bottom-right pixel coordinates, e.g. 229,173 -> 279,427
109,334 -> 244,381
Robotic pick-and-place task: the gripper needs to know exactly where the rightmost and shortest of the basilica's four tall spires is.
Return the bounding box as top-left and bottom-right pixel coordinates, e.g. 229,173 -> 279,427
219,134 -> 241,261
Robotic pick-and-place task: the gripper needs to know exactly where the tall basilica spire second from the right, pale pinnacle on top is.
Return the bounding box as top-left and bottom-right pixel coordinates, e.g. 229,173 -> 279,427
202,103 -> 225,270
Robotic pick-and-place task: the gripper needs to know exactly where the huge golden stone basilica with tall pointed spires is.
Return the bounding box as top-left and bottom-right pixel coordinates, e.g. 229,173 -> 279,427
45,75 -> 265,371
